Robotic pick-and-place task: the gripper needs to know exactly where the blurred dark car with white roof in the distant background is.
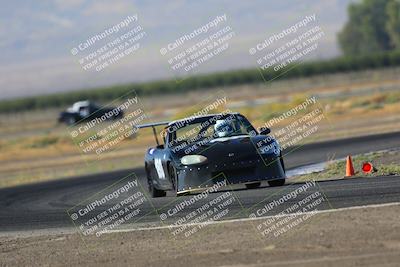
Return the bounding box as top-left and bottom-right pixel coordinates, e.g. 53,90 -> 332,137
58,100 -> 124,125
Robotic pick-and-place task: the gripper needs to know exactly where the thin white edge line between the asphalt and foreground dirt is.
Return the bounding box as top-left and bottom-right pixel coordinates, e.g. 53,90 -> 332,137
104,202 -> 400,234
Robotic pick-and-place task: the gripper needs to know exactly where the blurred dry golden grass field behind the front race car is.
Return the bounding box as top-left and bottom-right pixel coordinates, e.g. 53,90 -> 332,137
0,68 -> 400,187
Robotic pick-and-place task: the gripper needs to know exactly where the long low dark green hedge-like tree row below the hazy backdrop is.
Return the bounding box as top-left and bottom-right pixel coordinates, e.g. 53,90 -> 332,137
0,51 -> 400,113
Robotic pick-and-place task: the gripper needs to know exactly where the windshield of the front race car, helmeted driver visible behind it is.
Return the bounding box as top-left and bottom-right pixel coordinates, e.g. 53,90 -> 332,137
170,116 -> 255,145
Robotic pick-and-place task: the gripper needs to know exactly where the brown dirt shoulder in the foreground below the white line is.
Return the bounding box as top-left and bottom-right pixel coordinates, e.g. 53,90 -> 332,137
0,205 -> 400,267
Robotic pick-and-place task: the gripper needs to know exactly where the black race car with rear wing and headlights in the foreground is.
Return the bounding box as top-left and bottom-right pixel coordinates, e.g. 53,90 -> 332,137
136,113 -> 286,197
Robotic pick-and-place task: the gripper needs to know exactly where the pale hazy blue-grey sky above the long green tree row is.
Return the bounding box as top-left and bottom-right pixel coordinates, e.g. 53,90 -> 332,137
0,0 -> 351,98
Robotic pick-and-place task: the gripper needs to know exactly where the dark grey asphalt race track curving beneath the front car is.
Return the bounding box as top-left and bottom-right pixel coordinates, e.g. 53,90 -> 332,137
0,132 -> 400,232
